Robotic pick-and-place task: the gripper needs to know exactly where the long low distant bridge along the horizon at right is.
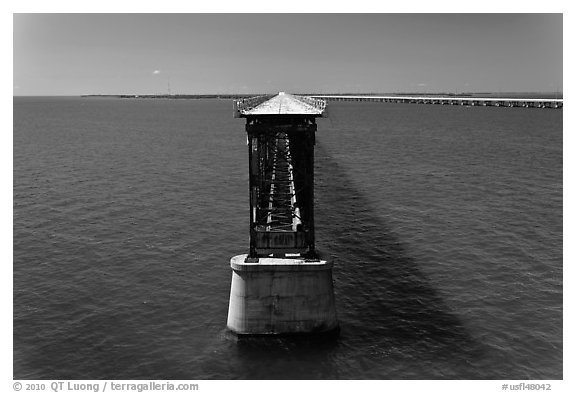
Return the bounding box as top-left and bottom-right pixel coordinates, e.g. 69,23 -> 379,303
310,95 -> 564,109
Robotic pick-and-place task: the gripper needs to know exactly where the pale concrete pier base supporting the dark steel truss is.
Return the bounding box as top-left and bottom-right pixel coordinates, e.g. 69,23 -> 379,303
227,254 -> 338,335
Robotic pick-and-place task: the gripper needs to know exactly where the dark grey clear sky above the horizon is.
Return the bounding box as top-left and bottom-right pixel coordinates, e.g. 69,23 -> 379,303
13,13 -> 563,96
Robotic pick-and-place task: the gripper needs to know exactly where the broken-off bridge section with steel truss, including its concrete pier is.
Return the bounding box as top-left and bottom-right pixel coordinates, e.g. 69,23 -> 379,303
228,92 -> 338,334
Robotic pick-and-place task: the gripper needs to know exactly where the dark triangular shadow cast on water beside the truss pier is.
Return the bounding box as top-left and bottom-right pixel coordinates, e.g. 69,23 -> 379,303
316,142 -> 482,370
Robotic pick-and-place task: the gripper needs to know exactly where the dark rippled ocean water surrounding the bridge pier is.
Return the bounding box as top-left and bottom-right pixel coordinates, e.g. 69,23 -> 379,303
13,97 -> 563,380
